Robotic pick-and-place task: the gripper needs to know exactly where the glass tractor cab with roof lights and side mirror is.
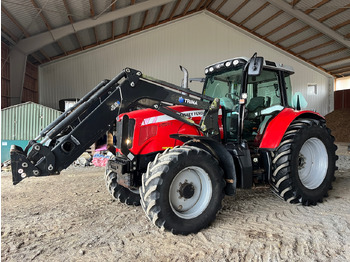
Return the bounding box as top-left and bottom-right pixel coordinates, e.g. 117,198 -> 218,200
203,56 -> 294,147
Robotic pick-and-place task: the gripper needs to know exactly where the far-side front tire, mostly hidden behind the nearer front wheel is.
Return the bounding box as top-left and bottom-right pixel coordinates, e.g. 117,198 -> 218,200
105,169 -> 140,206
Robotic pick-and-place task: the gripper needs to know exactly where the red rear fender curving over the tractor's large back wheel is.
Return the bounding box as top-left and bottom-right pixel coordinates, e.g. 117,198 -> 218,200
259,108 -> 324,150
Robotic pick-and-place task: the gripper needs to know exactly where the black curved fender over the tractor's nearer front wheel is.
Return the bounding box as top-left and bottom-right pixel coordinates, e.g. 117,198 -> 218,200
170,134 -> 237,196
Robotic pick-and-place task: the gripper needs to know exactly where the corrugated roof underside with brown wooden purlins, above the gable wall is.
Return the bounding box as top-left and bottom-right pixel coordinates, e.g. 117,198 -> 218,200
1,0 -> 350,77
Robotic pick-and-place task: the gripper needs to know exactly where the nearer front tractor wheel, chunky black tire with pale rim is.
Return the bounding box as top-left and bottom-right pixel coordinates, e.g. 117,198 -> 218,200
140,146 -> 225,235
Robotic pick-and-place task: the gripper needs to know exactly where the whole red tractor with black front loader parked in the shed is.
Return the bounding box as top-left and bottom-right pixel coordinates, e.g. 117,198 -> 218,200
11,54 -> 337,235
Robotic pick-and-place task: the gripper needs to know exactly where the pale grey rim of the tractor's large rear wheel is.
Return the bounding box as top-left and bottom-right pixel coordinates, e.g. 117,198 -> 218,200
298,137 -> 328,189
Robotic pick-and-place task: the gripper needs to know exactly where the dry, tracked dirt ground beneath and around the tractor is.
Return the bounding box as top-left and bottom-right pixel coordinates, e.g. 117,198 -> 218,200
1,146 -> 350,261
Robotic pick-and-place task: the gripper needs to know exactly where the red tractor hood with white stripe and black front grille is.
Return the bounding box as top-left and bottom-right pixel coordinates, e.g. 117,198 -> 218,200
117,105 -> 208,155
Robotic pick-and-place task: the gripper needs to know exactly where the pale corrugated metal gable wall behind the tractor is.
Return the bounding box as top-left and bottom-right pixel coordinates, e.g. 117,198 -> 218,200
39,13 -> 333,115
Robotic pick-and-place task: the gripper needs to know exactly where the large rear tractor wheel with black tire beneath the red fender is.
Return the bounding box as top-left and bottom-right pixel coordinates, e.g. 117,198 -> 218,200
271,119 -> 338,206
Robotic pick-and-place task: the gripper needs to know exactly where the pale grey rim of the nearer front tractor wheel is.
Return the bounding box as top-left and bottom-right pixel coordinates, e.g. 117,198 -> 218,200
169,166 -> 213,219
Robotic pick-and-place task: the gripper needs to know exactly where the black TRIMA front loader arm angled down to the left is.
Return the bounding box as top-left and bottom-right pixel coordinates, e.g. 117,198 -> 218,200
11,68 -> 219,185
